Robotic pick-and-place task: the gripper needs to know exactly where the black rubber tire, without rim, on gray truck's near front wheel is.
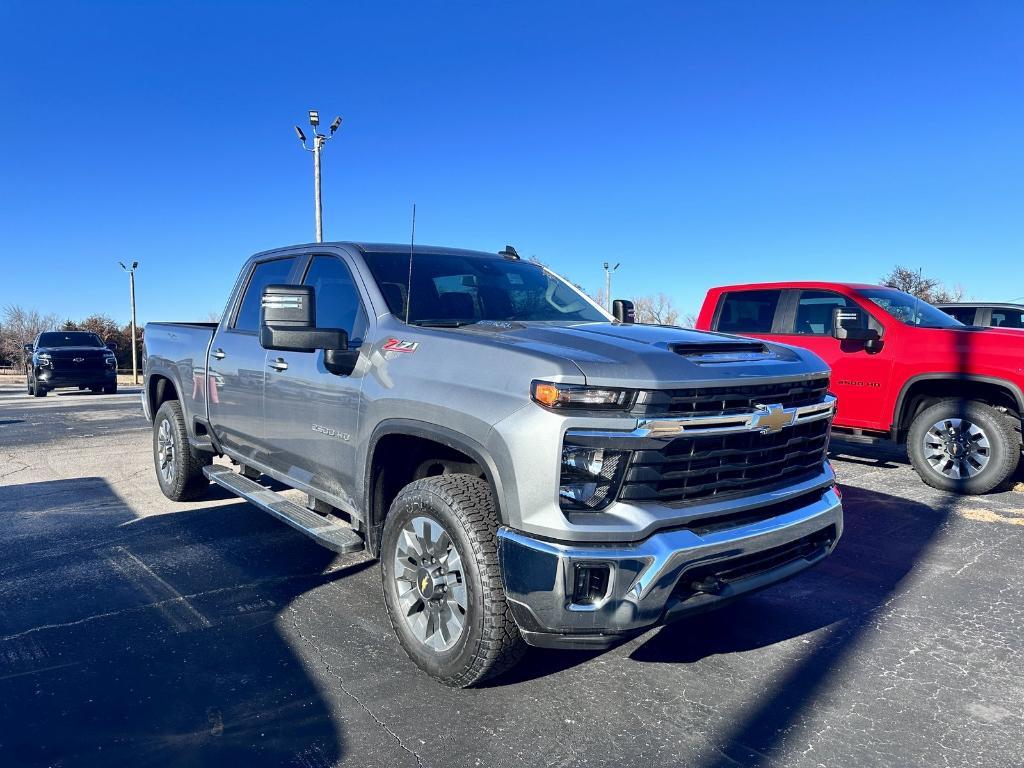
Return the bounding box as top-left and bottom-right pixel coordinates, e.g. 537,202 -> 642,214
381,474 -> 526,688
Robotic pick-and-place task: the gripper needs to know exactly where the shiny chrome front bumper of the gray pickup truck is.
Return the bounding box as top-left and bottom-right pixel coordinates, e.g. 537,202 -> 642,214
498,487 -> 843,648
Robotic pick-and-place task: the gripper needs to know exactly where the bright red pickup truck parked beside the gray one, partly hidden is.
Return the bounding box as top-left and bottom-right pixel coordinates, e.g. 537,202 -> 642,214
696,283 -> 1024,494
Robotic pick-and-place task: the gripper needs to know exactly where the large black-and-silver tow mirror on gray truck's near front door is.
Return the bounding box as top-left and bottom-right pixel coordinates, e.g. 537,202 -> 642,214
259,285 -> 348,360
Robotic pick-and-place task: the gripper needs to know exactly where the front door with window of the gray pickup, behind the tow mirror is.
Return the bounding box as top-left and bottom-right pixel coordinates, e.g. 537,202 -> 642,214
263,254 -> 368,509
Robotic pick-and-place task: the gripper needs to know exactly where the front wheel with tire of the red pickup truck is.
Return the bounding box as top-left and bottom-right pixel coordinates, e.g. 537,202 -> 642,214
907,399 -> 1021,495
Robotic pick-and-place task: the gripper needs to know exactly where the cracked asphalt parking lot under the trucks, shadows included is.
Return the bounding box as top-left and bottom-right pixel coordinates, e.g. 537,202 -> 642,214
0,386 -> 1024,768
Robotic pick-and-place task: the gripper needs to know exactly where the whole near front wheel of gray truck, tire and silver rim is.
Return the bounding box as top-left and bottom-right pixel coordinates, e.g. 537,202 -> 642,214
381,474 -> 526,688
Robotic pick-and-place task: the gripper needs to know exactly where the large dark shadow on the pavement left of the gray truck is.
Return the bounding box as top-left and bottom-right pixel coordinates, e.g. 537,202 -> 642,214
0,477 -> 369,768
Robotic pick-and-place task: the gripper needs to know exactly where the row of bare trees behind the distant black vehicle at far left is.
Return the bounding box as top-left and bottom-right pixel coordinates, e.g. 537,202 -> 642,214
0,304 -> 142,369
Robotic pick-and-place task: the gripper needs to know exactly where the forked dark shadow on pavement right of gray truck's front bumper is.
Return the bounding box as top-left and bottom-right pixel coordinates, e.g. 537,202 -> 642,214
632,486 -> 952,768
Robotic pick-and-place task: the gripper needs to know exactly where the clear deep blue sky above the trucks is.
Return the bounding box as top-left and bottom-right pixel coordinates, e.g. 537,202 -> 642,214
0,0 -> 1024,321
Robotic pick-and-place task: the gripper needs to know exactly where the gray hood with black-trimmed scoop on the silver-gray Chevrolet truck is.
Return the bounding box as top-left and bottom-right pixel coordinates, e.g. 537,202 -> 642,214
456,322 -> 828,388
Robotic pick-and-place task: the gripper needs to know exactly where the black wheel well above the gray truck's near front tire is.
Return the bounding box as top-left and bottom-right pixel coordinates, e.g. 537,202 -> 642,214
367,433 -> 489,555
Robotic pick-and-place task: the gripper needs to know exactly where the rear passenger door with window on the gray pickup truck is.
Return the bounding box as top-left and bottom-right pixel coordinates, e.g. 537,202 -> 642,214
209,256 -> 297,464
